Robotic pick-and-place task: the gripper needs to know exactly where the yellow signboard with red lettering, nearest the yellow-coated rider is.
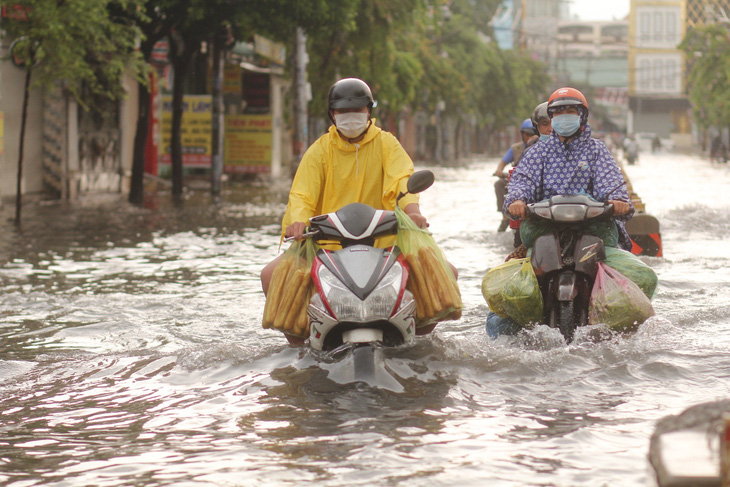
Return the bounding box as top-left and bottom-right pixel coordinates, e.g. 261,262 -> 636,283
223,115 -> 271,173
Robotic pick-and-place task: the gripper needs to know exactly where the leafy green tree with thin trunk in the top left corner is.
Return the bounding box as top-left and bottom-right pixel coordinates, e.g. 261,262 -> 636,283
2,0 -> 145,224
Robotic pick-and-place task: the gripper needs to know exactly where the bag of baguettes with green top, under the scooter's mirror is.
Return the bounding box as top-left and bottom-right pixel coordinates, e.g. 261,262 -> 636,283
395,207 -> 462,328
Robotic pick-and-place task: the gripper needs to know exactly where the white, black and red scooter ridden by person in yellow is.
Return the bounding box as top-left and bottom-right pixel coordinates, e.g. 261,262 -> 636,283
305,170 -> 434,375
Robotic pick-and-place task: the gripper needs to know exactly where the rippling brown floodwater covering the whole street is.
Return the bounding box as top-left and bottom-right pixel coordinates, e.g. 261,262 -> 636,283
0,153 -> 730,487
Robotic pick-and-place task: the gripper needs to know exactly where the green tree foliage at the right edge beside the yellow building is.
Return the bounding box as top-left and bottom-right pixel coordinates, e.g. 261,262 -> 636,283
679,25 -> 730,128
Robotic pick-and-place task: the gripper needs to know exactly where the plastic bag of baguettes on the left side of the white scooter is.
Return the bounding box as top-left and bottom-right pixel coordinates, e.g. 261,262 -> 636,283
262,238 -> 319,338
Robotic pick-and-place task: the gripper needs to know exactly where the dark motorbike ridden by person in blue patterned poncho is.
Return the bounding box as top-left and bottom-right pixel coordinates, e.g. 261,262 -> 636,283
526,195 -> 613,342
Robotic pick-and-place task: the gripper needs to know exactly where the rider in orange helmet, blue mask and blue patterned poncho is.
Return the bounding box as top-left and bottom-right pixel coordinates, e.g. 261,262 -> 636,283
504,87 -> 634,251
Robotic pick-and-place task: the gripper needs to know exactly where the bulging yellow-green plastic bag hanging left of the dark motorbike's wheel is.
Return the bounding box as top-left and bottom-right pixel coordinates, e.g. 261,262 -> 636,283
482,258 -> 543,326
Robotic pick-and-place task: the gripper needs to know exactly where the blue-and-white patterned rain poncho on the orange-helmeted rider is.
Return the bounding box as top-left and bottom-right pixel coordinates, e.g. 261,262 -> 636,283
503,125 -> 634,250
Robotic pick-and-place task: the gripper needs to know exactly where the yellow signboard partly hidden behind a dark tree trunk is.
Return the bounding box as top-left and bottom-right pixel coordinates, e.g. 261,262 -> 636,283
160,95 -> 213,167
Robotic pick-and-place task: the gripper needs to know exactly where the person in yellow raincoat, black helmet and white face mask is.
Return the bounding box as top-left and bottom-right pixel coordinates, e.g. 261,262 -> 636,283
261,78 -> 428,341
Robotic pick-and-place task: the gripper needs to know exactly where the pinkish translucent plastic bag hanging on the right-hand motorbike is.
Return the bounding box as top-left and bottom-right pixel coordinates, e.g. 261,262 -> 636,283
588,262 -> 654,331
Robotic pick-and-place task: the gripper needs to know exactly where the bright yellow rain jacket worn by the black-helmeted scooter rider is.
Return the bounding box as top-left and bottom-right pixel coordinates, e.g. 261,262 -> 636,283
281,119 -> 418,247
